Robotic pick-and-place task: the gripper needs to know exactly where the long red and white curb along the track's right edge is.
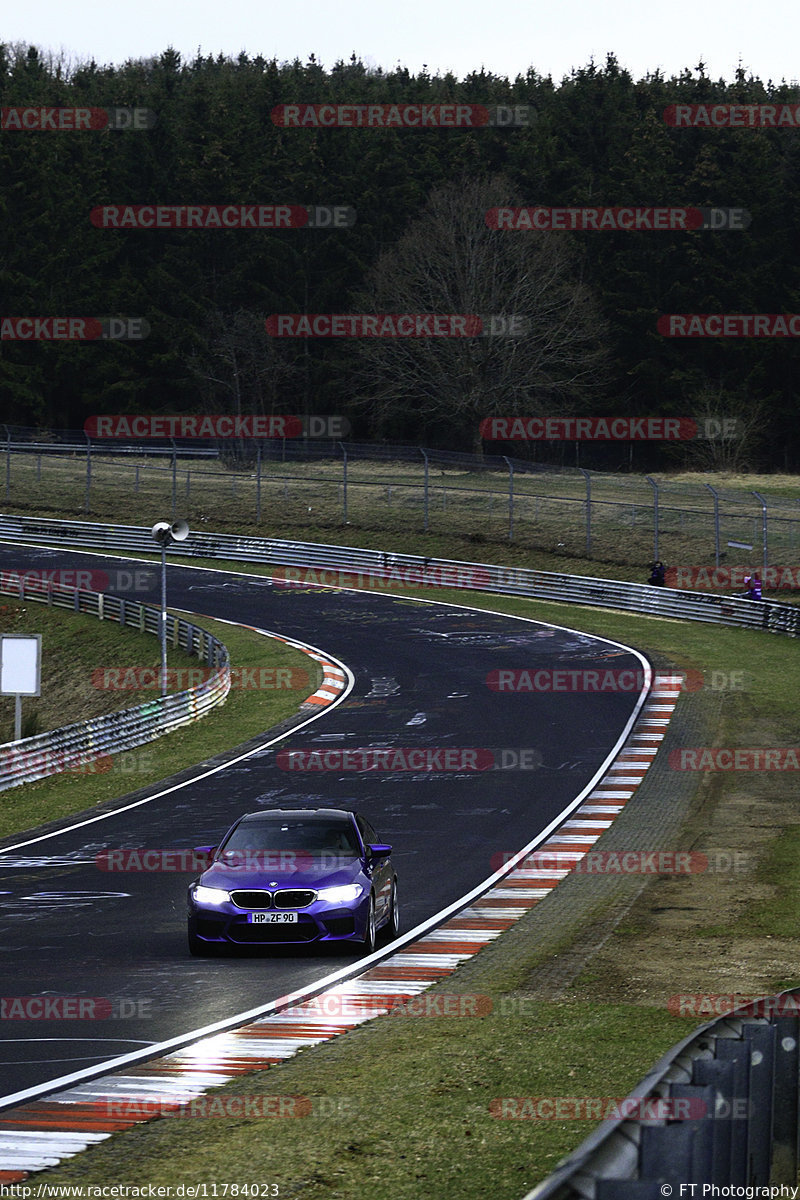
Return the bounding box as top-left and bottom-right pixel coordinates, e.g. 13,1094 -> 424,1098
0,676 -> 682,1183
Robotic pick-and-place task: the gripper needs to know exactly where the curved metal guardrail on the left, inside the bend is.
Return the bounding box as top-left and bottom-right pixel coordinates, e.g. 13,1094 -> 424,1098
0,574 -> 230,791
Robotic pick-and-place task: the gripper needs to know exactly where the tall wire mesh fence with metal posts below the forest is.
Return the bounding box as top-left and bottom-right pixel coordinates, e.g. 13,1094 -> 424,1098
0,425 -> 800,568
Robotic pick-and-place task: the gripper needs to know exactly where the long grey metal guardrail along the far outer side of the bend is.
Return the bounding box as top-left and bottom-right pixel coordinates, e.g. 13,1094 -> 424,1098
0,515 -> 800,637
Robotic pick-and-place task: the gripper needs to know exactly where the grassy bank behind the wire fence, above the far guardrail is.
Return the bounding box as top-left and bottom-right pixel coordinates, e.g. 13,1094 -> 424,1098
5,454 -> 800,574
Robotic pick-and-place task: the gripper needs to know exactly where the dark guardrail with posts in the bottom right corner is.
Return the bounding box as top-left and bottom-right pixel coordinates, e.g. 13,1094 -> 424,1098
524,989 -> 800,1200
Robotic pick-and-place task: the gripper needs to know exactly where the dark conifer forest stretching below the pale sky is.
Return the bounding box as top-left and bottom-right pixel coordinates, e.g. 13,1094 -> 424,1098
0,46 -> 800,469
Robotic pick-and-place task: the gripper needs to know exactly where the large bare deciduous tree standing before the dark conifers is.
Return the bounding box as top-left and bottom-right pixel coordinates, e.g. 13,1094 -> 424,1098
354,176 -> 604,448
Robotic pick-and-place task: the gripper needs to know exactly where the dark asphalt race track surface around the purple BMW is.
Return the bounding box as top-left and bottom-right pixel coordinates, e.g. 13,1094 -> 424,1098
0,546 -> 642,1103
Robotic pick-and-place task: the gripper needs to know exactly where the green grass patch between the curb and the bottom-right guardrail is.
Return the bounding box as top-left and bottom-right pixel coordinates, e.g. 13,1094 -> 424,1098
32,997 -> 692,1200
